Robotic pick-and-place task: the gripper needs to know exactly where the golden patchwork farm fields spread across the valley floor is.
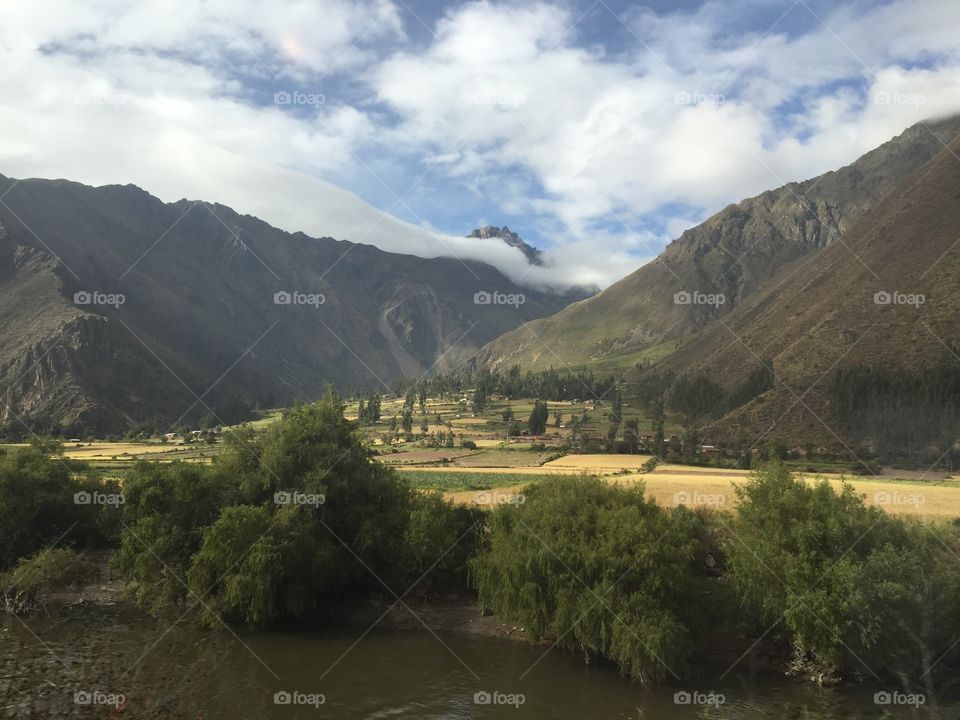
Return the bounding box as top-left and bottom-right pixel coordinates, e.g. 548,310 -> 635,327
9,399 -> 960,519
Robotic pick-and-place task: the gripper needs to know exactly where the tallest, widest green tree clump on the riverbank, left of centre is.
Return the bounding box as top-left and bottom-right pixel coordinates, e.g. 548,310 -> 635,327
118,391 -> 473,624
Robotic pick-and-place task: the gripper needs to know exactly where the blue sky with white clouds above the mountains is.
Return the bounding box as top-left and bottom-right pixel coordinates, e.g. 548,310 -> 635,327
0,0 -> 960,287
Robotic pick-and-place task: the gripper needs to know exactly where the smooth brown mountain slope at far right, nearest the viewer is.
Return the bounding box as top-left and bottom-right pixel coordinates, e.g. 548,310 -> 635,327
659,129 -> 960,452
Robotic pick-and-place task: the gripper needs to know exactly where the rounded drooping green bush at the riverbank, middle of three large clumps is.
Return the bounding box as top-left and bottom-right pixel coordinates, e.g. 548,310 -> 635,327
471,477 -> 716,683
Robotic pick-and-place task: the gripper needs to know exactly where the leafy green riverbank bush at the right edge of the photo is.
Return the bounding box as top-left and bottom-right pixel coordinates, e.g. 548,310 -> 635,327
726,464 -> 960,677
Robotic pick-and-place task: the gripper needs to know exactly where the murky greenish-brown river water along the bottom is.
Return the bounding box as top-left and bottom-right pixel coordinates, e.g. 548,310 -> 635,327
0,608 -> 960,720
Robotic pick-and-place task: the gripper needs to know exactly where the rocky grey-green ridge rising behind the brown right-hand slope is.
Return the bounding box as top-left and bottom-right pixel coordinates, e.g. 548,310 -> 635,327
475,116 -> 960,371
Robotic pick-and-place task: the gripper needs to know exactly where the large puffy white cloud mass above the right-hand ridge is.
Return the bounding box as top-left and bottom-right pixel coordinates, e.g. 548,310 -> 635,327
373,0 -> 960,256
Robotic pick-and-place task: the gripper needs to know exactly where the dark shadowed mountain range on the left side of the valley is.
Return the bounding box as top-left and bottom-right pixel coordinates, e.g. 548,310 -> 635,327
0,176 -> 584,433
